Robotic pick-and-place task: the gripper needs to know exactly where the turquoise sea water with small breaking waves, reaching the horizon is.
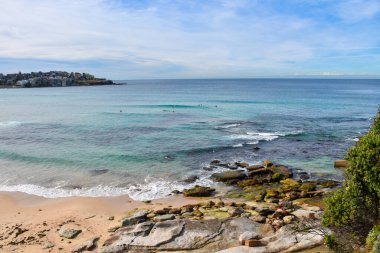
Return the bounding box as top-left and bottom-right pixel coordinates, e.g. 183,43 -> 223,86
0,79 -> 380,199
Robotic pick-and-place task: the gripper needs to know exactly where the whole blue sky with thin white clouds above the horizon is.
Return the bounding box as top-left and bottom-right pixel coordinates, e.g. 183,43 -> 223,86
0,0 -> 380,80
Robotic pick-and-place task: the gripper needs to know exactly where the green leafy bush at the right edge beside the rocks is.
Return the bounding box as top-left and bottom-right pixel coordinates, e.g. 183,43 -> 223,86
322,108 -> 380,252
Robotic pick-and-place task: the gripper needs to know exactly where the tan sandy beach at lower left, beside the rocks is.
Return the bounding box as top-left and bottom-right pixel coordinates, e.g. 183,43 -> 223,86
0,192 -> 200,253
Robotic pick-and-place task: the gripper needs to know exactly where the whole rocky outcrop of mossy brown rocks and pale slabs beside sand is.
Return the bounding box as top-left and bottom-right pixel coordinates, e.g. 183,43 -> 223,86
100,160 -> 339,253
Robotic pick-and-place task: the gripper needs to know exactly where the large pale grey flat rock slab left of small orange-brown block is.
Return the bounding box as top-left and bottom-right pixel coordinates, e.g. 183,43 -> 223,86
100,218 -> 273,253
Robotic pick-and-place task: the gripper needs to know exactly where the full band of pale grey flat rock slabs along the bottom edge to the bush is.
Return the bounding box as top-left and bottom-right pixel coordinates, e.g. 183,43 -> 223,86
100,218 -> 323,253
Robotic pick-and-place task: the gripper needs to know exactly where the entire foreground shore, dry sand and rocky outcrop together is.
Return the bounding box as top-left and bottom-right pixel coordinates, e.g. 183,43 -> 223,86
0,160 -> 339,253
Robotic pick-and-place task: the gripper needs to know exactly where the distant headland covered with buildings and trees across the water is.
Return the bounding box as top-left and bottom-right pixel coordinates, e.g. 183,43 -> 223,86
0,71 -> 114,88
